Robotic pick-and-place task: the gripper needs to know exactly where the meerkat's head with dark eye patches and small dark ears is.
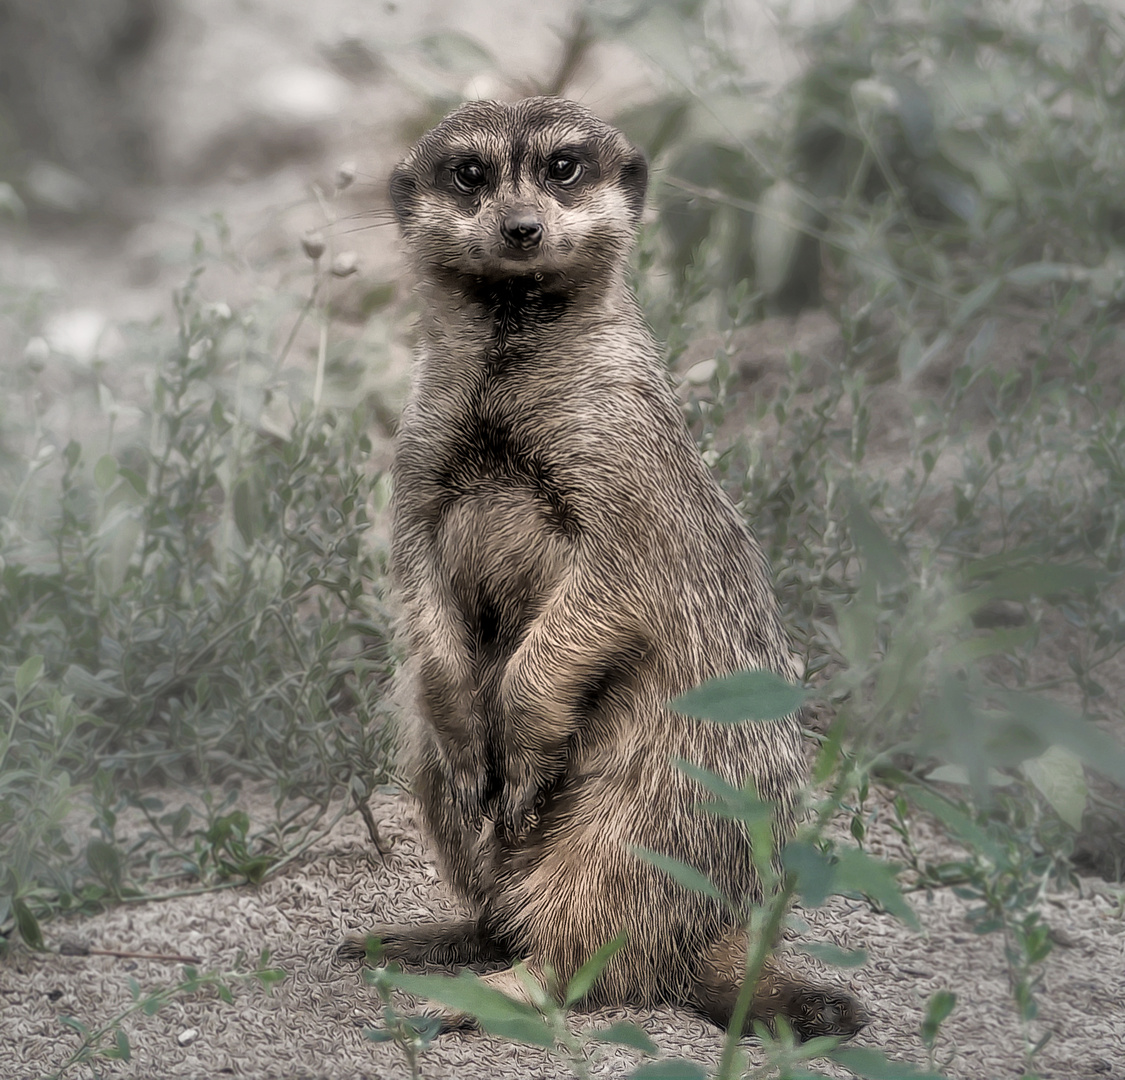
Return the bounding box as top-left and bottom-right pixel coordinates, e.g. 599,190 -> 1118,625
390,98 -> 648,284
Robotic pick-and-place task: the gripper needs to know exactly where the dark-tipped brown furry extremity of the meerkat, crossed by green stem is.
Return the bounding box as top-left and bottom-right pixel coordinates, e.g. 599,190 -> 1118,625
691,932 -> 867,1042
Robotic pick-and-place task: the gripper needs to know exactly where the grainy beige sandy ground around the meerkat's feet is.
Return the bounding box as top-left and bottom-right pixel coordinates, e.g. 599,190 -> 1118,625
0,793 -> 1125,1080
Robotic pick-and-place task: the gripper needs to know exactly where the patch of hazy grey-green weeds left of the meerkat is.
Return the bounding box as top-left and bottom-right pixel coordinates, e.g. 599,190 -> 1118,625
0,229 -> 390,944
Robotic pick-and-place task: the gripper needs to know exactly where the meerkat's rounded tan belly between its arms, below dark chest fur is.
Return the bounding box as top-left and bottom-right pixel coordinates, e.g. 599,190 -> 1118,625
429,484 -> 570,662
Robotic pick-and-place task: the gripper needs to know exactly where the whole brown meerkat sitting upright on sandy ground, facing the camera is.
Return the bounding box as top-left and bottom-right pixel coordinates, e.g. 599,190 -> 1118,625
340,98 -> 864,1037
